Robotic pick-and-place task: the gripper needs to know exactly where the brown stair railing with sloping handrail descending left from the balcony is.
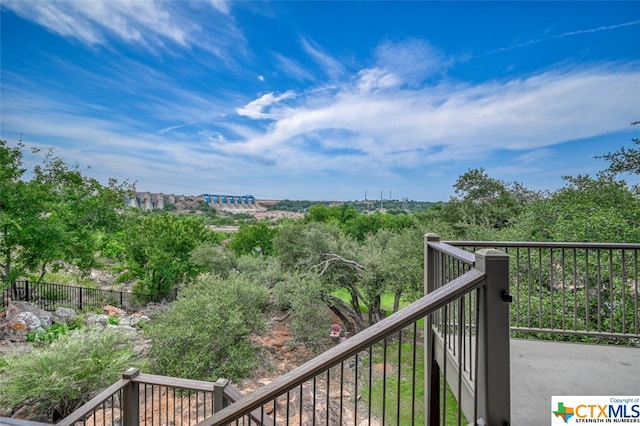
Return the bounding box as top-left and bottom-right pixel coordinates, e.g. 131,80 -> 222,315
0,234 -> 511,426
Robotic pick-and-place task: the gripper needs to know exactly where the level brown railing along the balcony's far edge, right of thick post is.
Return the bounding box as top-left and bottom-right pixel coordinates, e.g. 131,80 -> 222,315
448,241 -> 640,345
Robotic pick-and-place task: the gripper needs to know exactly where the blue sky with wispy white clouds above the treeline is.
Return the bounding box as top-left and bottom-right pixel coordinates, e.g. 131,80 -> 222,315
0,0 -> 640,201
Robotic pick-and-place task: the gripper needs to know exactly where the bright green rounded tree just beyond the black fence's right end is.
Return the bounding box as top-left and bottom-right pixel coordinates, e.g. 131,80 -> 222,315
116,213 -> 217,300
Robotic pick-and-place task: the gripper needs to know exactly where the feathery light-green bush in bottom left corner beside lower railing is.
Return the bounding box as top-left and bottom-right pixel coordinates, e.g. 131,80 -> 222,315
0,329 -> 140,420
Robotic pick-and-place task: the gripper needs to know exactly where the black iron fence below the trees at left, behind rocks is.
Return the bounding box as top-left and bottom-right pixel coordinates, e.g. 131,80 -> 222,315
0,280 -> 177,311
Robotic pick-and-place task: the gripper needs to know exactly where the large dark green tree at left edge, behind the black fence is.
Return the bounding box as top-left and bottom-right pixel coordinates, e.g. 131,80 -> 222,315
0,141 -> 131,292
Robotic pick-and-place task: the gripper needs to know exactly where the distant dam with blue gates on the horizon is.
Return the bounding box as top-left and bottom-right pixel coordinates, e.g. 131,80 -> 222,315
126,192 -> 272,212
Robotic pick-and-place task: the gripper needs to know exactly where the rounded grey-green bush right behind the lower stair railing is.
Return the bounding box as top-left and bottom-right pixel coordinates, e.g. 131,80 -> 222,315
145,274 -> 269,381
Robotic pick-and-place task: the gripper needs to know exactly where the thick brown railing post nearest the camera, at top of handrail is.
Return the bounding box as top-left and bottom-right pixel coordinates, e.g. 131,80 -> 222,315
475,249 -> 511,426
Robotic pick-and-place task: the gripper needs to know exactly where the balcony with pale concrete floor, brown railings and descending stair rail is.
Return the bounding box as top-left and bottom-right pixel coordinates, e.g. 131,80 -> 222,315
0,234 -> 640,426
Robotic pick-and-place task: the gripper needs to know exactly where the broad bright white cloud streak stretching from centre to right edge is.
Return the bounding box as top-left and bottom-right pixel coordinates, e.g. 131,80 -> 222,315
219,62 -> 640,175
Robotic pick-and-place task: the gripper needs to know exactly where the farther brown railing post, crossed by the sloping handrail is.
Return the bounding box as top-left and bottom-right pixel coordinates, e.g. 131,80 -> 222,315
424,234 -> 440,425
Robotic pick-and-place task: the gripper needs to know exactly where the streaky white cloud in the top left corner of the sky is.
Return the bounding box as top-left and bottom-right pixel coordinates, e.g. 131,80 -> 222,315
2,0 -> 245,59
